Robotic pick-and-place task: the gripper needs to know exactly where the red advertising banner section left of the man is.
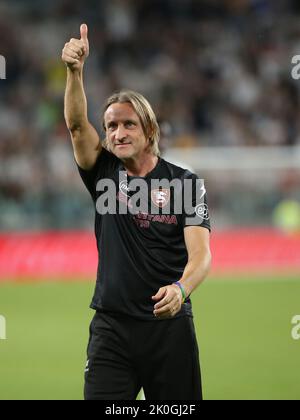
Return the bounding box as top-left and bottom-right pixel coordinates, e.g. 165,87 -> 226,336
0,232 -> 98,280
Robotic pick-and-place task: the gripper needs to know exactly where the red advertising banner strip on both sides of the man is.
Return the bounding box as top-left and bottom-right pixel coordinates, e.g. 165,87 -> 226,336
0,229 -> 300,281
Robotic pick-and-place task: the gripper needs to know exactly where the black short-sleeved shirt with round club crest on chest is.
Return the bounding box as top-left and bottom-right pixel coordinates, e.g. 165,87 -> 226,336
79,149 -> 210,320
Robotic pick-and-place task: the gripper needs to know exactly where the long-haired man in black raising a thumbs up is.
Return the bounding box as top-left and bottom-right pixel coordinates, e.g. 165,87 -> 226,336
62,25 -> 211,400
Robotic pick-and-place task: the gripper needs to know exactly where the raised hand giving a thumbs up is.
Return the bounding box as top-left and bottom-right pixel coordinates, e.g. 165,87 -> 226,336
62,24 -> 90,71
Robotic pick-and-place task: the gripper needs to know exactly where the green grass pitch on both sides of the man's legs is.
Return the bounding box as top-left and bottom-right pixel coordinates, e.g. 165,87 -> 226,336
0,277 -> 300,399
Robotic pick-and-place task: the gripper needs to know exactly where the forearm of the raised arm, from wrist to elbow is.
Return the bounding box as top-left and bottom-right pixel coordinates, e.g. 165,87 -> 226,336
65,69 -> 88,131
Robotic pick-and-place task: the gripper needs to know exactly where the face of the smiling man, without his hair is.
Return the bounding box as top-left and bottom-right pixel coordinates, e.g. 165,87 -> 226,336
104,103 -> 149,160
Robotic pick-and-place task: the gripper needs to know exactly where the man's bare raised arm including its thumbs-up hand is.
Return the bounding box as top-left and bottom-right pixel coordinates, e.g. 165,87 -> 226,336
62,24 -> 102,170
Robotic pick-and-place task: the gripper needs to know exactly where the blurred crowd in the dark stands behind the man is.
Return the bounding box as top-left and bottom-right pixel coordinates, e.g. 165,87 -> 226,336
0,0 -> 300,229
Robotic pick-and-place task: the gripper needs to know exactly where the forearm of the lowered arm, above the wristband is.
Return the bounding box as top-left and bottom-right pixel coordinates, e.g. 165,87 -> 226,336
180,249 -> 211,296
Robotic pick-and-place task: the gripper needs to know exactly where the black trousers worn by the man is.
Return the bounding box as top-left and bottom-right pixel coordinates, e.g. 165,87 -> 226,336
84,312 -> 202,401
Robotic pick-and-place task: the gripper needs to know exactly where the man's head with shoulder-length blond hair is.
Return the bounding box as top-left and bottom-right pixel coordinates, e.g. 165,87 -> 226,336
103,91 -> 160,159
